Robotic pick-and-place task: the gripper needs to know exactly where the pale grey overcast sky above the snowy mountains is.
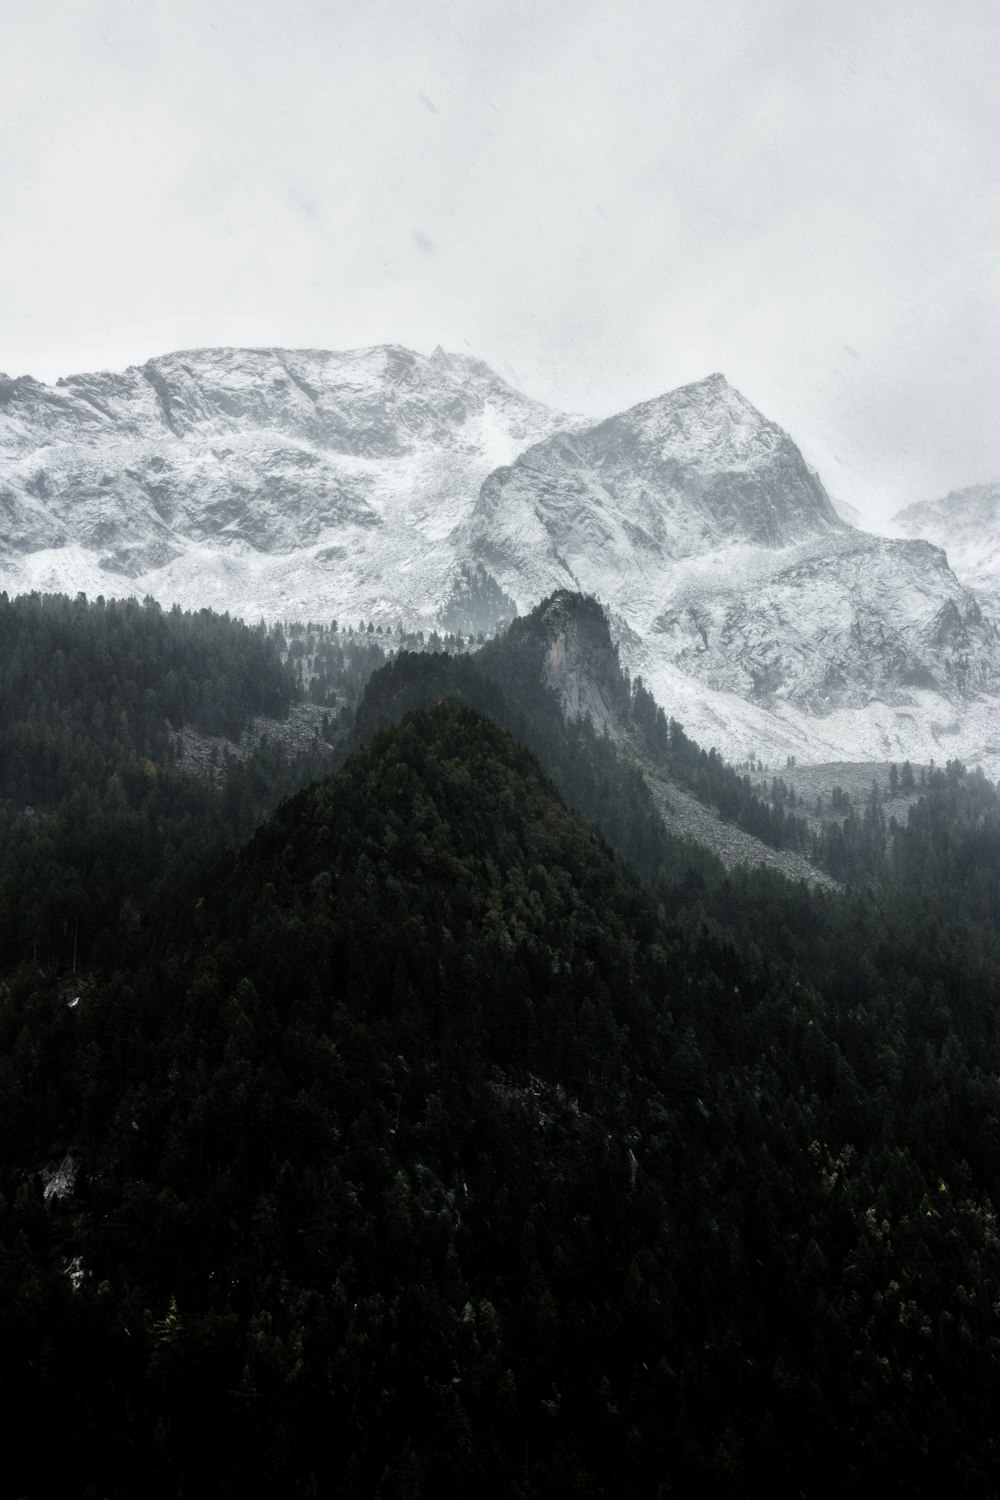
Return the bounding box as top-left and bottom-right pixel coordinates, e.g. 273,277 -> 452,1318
0,0 -> 1000,515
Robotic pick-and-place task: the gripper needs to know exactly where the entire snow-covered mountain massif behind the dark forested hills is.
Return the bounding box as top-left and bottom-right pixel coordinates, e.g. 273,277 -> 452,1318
0,347 -> 1000,776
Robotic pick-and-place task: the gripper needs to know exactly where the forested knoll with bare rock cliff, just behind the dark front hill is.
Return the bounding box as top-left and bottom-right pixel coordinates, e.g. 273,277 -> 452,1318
352,591 -> 807,882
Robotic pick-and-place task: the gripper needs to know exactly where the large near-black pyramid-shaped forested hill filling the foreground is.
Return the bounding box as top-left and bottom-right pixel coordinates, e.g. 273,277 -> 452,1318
0,702 -> 1000,1500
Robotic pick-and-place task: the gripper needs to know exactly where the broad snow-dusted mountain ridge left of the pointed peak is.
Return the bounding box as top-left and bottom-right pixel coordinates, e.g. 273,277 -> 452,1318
0,347 -> 568,621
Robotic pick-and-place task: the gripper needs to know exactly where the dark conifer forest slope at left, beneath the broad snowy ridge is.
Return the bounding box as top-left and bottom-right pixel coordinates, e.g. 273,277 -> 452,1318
0,594 -> 324,971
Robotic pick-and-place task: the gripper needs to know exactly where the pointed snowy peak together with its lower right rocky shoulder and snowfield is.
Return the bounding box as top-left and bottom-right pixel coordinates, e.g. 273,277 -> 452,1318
465,375 -> 1000,774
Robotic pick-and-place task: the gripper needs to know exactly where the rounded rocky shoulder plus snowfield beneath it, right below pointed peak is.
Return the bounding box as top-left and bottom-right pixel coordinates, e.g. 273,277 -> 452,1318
622,530 -> 1000,777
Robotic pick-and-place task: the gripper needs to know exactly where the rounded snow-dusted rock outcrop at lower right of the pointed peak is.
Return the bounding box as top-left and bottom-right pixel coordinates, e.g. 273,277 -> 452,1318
654,531 -> 1000,714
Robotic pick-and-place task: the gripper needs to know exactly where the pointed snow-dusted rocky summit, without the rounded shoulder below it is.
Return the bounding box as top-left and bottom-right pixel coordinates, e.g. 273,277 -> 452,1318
468,375 -> 844,603
